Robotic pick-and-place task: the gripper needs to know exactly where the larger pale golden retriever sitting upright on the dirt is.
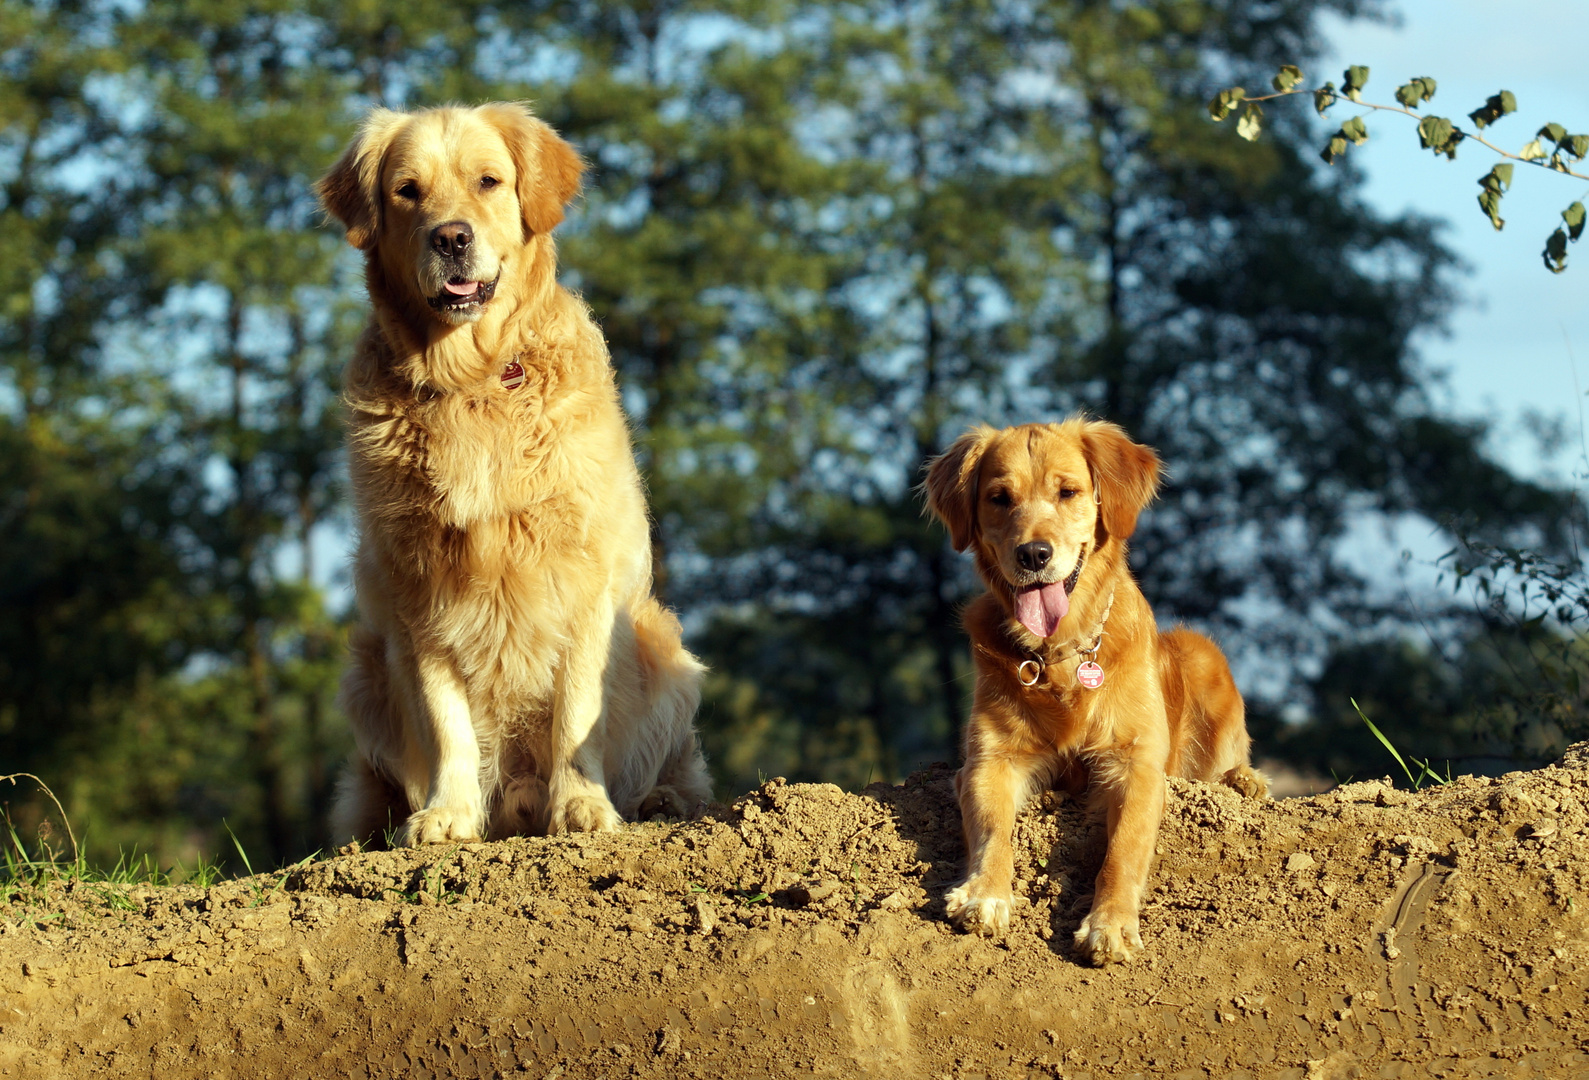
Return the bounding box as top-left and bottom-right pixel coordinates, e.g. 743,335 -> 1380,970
318,103 -> 710,845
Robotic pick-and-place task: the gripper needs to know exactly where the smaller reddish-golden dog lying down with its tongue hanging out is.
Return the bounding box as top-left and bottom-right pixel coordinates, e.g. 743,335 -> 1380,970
925,418 -> 1268,964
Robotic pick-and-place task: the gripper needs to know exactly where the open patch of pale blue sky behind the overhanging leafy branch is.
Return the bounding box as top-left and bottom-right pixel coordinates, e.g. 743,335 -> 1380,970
1308,0 -> 1589,478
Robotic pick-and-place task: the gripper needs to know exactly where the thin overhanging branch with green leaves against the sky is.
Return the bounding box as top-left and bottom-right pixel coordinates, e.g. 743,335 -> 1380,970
1208,64 -> 1589,273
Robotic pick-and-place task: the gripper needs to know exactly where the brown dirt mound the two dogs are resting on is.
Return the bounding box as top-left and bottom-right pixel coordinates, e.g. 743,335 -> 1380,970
0,745 -> 1589,1080
